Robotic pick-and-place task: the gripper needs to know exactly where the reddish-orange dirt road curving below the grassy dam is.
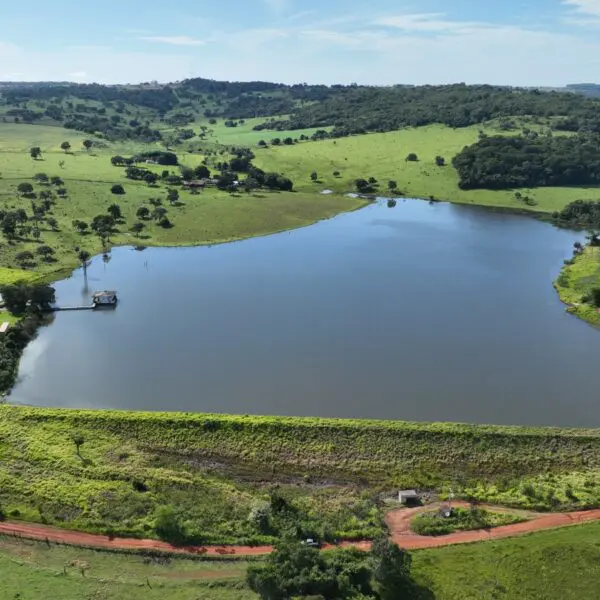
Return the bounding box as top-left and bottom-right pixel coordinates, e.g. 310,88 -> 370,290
0,502 -> 600,556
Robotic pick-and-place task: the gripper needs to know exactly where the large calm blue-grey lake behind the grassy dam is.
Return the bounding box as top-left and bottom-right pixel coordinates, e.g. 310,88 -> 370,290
5,198 -> 600,426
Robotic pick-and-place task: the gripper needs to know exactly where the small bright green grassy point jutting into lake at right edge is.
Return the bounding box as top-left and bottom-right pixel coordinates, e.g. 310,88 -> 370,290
554,246 -> 600,326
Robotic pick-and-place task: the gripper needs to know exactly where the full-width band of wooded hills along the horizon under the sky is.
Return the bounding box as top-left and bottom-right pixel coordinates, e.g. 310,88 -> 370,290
0,78 -> 600,141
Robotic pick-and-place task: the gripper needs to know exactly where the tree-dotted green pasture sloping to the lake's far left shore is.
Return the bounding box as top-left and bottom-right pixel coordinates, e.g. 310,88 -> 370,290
0,123 -> 366,283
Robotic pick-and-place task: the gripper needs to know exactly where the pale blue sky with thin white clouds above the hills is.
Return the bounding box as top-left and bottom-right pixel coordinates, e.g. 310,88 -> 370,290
0,0 -> 600,86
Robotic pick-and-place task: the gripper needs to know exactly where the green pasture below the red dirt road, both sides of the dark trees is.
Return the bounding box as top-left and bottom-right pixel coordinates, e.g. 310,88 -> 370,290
0,523 -> 600,600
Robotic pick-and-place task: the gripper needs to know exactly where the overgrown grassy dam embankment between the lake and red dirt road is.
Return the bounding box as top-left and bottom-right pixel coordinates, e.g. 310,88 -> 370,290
0,405 -> 600,543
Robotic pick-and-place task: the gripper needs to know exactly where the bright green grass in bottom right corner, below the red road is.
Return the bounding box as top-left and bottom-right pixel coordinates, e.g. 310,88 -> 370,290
413,523 -> 600,600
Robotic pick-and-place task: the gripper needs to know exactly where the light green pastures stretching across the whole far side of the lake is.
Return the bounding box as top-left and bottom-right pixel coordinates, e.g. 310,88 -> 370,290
0,119 -> 599,283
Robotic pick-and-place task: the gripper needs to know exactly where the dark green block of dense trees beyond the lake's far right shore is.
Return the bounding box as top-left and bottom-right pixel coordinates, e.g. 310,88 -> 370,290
452,134 -> 600,190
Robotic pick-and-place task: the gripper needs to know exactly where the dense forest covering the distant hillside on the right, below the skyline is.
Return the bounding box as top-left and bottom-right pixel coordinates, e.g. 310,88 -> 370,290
252,84 -> 600,133
